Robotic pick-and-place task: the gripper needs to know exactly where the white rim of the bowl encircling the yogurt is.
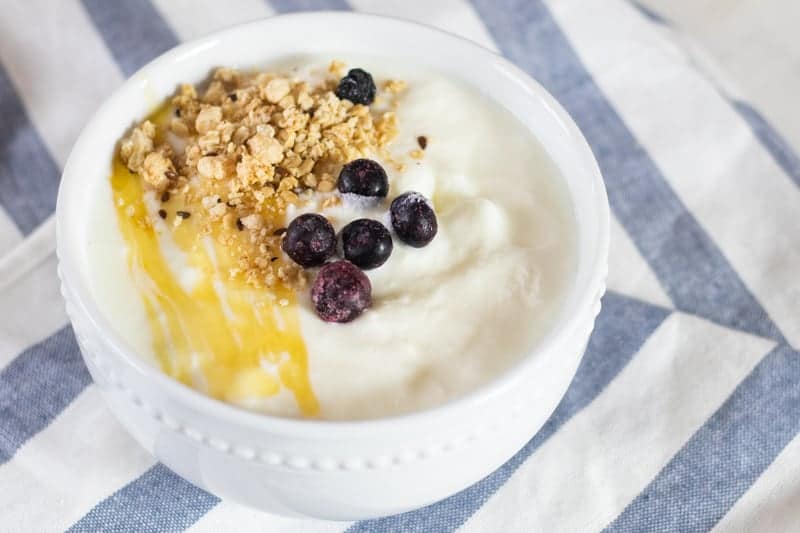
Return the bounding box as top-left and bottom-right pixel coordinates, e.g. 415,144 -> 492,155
57,13 -> 609,426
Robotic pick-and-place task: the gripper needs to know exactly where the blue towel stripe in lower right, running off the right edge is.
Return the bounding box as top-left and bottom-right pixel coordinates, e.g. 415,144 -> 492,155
607,346 -> 800,533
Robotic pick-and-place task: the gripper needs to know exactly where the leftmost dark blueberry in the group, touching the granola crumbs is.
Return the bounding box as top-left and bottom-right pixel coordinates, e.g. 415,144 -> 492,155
281,213 -> 336,267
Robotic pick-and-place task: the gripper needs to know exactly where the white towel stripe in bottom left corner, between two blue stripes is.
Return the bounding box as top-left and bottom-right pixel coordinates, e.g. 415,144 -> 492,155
0,385 -> 153,531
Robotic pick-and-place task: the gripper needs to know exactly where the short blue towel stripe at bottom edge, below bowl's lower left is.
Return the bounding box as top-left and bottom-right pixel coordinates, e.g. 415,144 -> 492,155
68,464 -> 219,533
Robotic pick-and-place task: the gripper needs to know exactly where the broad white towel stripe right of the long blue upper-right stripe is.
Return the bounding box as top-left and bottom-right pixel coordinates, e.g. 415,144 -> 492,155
551,0 -> 800,346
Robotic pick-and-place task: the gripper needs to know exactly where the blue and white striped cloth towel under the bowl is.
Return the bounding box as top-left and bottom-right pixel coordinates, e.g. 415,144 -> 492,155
0,0 -> 800,532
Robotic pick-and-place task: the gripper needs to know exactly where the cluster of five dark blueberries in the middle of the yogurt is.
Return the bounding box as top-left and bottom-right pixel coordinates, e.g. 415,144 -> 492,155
281,159 -> 438,322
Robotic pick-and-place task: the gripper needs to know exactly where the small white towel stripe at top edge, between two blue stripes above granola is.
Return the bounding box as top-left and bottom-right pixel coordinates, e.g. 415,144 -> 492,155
153,0 -> 273,41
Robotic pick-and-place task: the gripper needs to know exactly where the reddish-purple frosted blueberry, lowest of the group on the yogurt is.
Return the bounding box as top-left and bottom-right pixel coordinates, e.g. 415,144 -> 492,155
311,261 -> 372,322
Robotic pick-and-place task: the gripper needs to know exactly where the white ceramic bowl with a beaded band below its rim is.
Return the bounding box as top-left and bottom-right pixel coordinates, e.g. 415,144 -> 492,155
57,13 -> 609,520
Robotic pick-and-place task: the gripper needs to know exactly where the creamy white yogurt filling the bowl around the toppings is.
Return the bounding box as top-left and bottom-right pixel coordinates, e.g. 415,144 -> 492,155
87,58 -> 576,420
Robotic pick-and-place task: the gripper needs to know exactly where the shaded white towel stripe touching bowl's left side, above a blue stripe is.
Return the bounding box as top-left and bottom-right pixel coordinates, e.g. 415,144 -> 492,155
0,231 -> 67,368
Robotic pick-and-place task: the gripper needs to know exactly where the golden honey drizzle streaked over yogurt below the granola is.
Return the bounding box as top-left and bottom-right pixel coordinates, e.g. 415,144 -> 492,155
111,160 -> 319,416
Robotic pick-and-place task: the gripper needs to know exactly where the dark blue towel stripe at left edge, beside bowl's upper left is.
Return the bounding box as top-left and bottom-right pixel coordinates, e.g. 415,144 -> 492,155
0,61 -> 59,233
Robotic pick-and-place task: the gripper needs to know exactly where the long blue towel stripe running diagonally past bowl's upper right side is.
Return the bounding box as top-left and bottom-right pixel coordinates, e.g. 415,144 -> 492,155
474,0 -> 783,340
